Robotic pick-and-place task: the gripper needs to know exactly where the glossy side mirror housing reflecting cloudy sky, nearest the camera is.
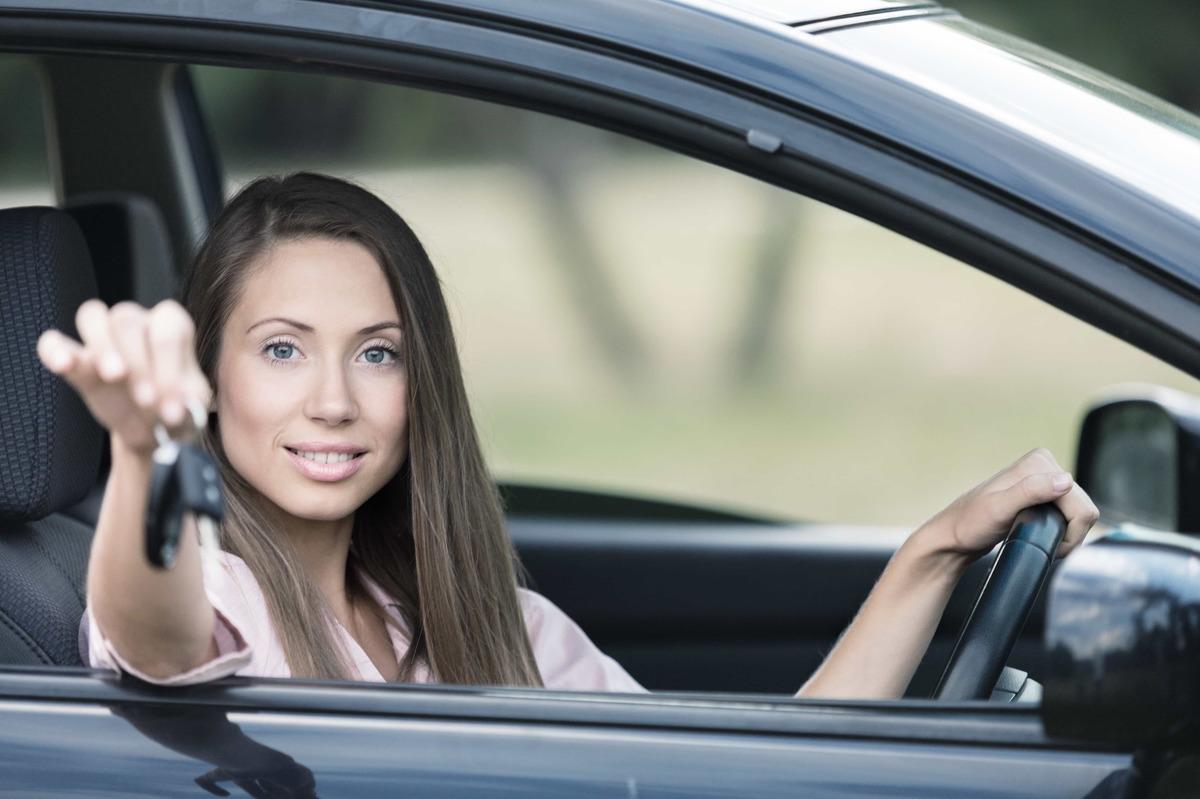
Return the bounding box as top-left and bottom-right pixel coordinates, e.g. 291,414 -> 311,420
1042,533 -> 1200,746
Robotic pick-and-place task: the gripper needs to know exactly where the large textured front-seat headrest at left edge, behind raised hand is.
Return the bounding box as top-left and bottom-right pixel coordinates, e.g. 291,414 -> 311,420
0,208 -> 103,521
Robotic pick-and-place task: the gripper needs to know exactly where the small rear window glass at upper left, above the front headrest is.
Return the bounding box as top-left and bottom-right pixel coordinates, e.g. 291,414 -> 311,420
0,54 -> 55,208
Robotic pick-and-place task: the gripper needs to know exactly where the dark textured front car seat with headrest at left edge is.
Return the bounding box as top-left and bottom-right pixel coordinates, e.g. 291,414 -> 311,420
0,208 -> 103,666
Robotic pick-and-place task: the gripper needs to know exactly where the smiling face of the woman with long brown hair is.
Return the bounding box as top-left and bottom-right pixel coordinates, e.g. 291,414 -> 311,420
216,239 -> 408,521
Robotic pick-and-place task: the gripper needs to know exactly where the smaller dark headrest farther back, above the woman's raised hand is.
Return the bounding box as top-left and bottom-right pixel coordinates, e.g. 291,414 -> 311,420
62,192 -> 175,308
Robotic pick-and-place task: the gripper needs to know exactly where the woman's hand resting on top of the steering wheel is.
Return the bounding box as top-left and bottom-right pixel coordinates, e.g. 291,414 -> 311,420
923,449 -> 1100,560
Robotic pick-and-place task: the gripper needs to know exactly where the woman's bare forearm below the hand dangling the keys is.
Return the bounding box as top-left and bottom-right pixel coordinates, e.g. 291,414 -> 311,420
88,437 -> 214,677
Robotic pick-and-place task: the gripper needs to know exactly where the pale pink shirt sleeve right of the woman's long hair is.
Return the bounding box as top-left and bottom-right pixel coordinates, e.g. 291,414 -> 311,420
517,588 -> 647,693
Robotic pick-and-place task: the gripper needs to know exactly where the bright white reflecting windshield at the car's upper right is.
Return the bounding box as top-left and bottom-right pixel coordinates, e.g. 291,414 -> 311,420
834,17 -> 1200,220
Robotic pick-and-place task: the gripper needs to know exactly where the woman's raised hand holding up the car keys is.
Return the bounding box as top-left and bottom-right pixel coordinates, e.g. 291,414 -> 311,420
37,300 -> 212,455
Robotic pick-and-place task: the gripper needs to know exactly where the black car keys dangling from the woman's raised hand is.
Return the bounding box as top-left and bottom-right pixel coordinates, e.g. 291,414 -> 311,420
145,405 -> 224,569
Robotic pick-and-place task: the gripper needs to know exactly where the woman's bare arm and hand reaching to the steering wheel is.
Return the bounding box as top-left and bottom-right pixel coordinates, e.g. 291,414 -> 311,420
797,449 -> 1099,699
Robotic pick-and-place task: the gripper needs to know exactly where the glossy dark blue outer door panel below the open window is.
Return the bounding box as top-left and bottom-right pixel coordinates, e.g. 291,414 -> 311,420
0,677 -> 1129,798
